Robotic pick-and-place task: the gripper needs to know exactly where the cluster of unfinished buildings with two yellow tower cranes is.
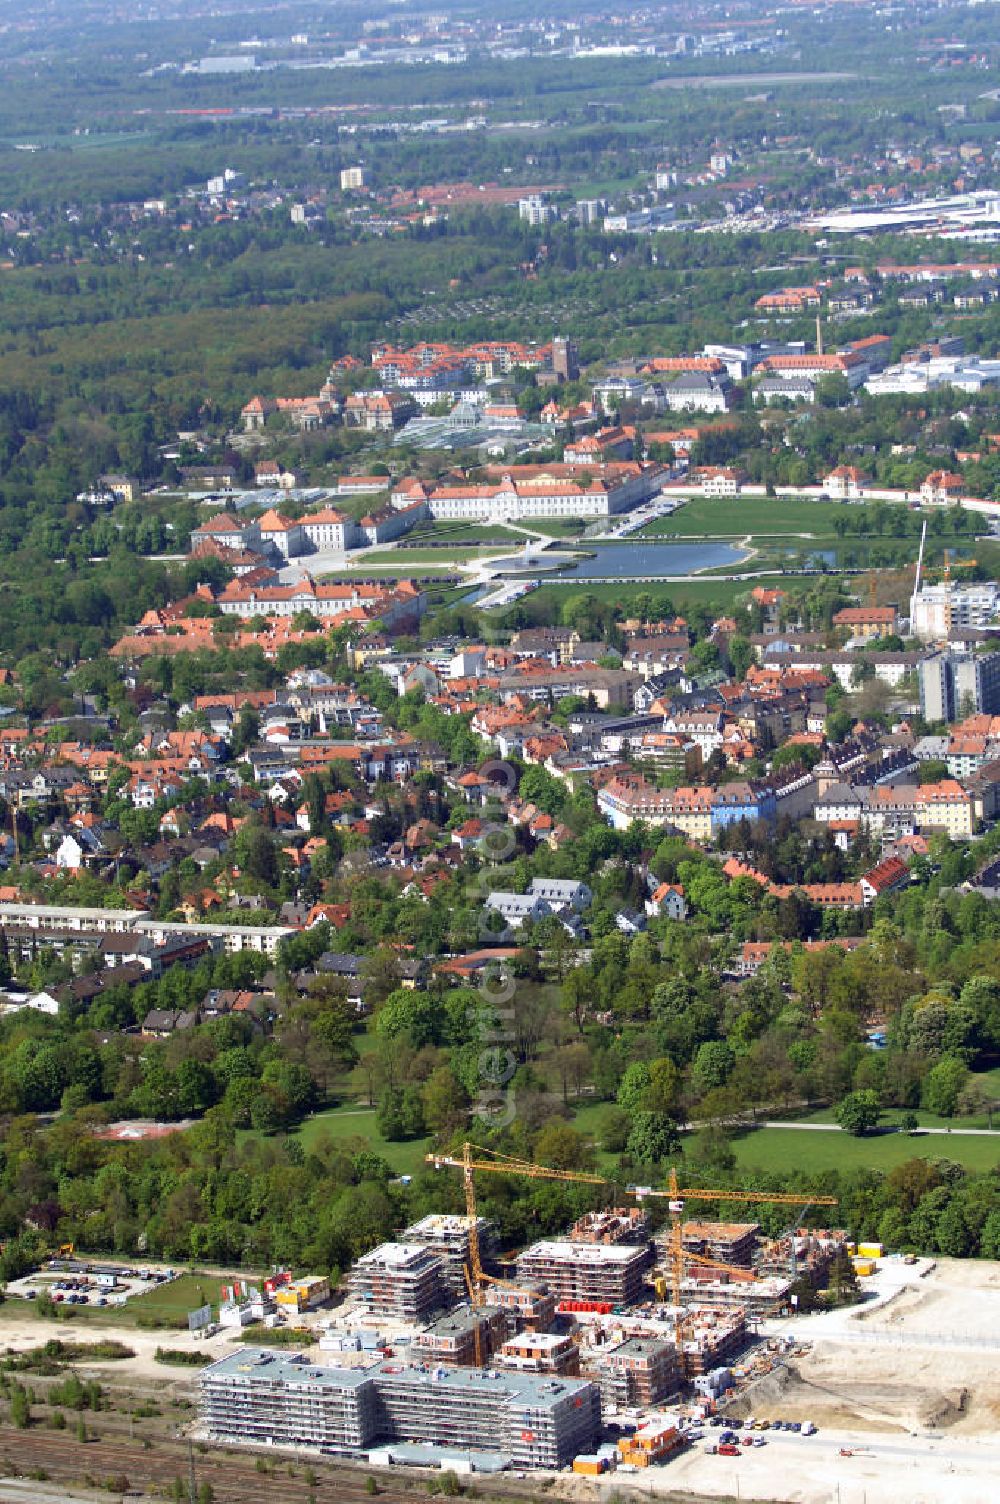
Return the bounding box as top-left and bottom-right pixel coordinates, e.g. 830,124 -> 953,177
202,1145 -> 848,1475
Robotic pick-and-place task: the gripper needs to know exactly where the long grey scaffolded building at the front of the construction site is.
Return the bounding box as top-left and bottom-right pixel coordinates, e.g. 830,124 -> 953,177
200,1348 -> 600,1468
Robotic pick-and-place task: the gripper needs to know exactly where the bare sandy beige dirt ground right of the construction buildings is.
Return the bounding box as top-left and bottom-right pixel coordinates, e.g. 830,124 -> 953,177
592,1259 -> 1000,1504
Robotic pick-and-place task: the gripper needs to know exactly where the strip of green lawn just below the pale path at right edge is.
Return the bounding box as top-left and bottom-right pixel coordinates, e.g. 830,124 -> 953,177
732,1128 -> 1000,1173
